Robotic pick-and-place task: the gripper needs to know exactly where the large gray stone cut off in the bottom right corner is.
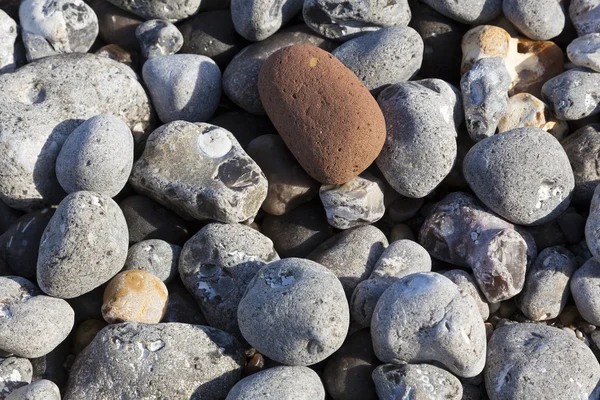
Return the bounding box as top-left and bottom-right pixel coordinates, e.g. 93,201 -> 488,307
485,323 -> 600,400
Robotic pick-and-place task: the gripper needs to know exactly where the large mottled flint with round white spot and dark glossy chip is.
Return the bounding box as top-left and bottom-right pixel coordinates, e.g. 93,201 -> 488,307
130,120 -> 267,222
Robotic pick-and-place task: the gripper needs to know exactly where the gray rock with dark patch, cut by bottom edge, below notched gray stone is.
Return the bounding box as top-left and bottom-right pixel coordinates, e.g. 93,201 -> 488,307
373,364 -> 463,400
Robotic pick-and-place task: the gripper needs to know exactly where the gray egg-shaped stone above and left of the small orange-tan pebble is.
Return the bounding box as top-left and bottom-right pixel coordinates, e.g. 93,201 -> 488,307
37,191 -> 129,299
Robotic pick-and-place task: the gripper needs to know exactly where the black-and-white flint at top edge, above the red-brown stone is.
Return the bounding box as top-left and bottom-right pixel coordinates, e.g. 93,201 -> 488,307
302,0 -> 411,41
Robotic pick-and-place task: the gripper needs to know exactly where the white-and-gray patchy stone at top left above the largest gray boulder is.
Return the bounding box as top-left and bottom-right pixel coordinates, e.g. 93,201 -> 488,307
19,0 -> 98,62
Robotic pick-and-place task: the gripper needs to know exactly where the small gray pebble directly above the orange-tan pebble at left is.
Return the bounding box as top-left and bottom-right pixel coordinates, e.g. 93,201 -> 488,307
123,239 -> 181,284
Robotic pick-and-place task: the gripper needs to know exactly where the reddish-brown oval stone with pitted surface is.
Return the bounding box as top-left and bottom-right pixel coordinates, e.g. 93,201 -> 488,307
258,45 -> 385,184
